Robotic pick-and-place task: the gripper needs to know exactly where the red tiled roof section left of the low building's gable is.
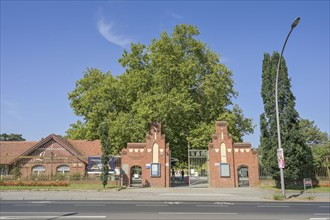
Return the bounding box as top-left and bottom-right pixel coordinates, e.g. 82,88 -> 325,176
0,141 -> 38,164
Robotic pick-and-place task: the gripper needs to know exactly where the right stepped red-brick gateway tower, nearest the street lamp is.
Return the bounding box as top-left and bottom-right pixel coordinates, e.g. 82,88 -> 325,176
208,121 -> 259,187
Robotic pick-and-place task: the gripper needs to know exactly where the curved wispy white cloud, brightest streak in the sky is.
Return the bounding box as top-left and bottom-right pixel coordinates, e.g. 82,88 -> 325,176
97,18 -> 132,48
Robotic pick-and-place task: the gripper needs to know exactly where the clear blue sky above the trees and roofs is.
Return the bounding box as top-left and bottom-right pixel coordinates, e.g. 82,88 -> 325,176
1,0 -> 330,147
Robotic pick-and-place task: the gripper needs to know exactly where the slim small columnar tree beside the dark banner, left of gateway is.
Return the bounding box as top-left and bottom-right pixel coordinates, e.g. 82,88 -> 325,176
99,122 -> 110,189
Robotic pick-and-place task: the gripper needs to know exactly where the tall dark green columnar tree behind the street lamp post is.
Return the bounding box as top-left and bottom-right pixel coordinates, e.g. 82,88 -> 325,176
260,52 -> 312,184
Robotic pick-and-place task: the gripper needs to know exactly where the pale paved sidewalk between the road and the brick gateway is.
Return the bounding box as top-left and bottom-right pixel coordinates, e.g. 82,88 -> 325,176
0,187 -> 330,202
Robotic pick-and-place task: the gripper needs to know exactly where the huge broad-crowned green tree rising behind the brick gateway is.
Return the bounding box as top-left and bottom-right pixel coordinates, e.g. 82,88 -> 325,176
67,25 -> 253,158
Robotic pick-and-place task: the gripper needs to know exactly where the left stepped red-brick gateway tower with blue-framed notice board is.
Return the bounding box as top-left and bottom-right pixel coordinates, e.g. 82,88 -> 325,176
121,123 -> 170,187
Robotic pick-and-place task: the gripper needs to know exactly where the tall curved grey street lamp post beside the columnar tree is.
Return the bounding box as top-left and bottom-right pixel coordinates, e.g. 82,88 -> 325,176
275,17 -> 300,198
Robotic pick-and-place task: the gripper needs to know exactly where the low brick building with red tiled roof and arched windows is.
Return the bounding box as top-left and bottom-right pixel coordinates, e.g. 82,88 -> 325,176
0,134 -> 101,178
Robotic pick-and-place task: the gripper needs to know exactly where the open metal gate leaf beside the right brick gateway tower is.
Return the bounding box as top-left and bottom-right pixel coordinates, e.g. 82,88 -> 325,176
188,149 -> 209,187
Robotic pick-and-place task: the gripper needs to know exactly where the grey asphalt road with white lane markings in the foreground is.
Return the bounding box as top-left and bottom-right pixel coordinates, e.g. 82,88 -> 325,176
0,200 -> 330,220
